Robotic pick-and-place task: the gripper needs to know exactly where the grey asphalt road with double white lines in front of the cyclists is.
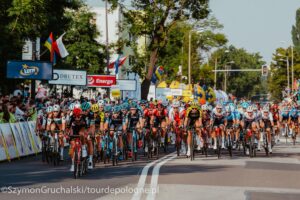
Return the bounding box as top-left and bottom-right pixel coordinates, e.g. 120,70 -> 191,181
0,140 -> 300,200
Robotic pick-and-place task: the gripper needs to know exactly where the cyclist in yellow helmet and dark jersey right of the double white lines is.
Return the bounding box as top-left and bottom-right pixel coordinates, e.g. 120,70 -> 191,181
184,102 -> 203,157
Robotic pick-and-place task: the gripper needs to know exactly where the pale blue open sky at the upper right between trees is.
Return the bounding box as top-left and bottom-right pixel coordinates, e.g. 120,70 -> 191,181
210,0 -> 300,63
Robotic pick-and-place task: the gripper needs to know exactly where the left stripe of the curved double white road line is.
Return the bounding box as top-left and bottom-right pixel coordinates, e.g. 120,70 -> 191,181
132,154 -> 176,200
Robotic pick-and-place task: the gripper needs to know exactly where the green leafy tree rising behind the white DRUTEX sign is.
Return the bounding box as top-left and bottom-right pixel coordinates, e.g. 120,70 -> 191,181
61,6 -> 104,74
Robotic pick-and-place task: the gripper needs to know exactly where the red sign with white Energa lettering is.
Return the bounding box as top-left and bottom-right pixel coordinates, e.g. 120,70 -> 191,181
87,75 -> 117,87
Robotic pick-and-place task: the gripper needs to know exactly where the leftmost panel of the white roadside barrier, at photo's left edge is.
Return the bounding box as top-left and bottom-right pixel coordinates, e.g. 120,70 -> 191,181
0,124 -> 19,159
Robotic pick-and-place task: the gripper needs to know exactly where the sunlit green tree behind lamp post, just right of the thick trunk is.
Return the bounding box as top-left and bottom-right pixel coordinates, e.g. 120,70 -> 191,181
157,18 -> 227,82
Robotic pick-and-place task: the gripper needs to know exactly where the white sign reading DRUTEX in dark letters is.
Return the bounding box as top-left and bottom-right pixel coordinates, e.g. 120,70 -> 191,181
49,69 -> 86,86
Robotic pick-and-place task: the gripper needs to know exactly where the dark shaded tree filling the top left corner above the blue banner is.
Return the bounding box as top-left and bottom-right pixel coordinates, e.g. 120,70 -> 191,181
0,0 -> 82,92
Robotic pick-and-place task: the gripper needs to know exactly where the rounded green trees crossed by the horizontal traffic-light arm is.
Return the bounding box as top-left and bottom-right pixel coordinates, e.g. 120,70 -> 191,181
211,46 -> 266,98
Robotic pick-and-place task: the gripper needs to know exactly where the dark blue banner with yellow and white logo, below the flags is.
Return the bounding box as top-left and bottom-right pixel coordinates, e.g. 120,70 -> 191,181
6,61 -> 53,80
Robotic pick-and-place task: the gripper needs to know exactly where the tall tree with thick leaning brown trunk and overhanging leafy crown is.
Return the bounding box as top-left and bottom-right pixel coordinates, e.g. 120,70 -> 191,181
111,0 -> 209,99
